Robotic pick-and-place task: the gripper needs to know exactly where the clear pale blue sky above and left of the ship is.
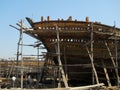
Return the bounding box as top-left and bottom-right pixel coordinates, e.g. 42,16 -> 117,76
0,0 -> 120,58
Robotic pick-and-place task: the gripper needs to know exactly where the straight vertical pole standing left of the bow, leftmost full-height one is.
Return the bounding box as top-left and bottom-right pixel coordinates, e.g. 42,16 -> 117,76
20,20 -> 23,88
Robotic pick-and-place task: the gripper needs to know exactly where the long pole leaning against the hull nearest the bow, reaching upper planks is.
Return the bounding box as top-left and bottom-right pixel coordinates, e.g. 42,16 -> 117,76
56,25 -> 68,87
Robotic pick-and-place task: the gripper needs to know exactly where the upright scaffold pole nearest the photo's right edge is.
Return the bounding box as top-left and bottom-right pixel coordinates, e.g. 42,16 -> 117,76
114,22 -> 119,86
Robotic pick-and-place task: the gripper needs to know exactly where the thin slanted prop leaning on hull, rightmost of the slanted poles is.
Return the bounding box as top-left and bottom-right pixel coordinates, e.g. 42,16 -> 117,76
105,41 -> 119,86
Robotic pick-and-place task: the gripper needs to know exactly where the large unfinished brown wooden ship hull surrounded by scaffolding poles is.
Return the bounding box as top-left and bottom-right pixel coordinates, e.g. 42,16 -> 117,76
0,16 -> 120,88
